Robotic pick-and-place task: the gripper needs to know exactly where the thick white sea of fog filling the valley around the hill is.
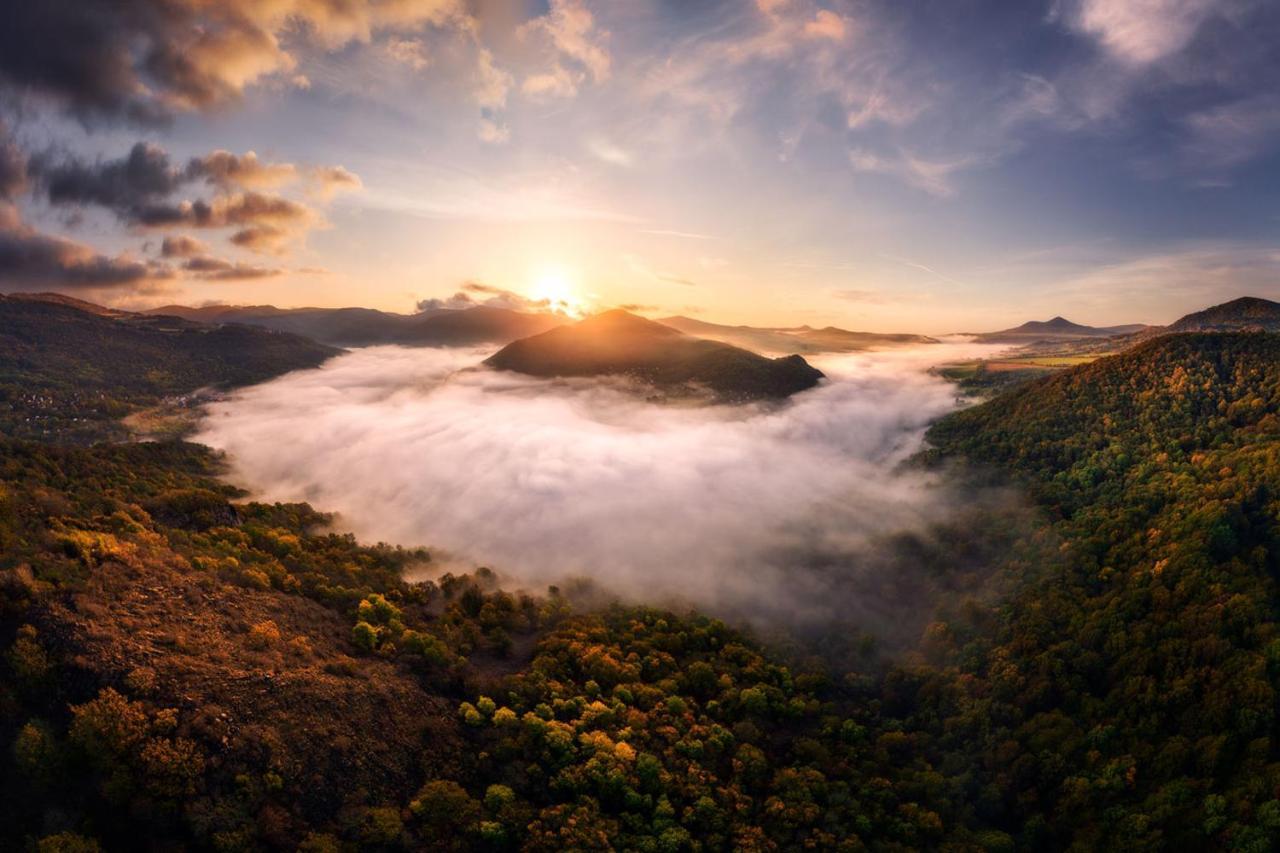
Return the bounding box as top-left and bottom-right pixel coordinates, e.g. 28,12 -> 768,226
196,343 -> 993,622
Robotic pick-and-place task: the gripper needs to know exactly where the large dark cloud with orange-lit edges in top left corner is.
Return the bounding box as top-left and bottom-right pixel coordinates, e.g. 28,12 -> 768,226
0,0 -> 471,122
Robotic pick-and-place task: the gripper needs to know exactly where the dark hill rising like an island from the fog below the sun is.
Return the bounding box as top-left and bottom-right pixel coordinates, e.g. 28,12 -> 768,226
485,310 -> 823,402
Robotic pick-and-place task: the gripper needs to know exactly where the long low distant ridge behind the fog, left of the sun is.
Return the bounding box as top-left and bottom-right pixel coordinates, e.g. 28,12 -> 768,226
147,305 -> 564,347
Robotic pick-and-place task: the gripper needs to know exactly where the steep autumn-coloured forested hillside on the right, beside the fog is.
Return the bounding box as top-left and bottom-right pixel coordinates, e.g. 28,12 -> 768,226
913,334 -> 1280,850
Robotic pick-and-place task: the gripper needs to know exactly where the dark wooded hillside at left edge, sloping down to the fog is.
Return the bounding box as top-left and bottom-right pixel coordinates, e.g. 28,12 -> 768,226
0,295 -> 339,441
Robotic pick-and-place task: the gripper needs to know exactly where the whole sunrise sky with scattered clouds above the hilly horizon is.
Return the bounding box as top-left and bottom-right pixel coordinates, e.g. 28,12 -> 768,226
0,0 -> 1280,333
